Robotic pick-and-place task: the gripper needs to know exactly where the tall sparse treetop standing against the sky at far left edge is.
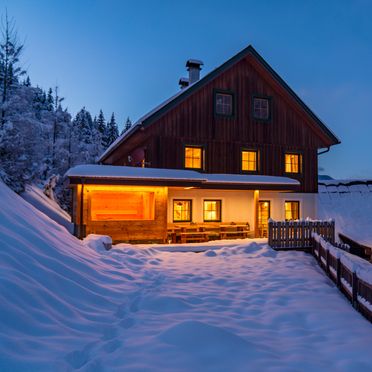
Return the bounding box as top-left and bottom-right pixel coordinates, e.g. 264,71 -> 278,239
0,13 -> 26,126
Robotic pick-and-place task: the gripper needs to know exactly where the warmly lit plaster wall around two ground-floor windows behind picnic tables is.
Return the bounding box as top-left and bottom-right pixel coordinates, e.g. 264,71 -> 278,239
168,188 -> 254,226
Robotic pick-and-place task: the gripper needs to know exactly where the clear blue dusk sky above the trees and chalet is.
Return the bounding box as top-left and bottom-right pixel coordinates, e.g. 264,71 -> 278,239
0,0 -> 372,178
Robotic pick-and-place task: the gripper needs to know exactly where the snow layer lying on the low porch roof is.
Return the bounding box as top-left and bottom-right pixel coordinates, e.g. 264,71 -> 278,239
66,165 -> 300,186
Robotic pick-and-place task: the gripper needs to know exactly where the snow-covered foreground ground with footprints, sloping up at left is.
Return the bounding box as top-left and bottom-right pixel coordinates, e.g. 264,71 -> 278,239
0,183 -> 372,371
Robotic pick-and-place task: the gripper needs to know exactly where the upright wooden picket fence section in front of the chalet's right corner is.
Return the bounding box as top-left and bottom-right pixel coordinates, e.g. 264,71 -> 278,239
269,219 -> 335,250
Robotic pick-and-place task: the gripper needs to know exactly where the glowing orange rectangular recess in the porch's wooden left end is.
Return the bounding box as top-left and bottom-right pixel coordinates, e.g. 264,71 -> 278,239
90,191 -> 155,221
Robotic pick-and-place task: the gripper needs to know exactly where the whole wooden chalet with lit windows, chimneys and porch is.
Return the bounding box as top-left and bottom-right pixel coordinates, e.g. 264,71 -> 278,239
68,46 -> 340,242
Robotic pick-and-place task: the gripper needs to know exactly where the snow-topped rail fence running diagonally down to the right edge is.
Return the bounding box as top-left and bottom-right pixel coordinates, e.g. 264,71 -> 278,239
312,233 -> 372,322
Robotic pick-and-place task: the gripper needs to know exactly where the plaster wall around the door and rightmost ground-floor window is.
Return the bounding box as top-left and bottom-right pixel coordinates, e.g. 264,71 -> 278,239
259,191 -> 318,221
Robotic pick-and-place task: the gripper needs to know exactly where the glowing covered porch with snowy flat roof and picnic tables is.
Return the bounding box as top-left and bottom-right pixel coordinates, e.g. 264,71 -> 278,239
68,165 -> 304,243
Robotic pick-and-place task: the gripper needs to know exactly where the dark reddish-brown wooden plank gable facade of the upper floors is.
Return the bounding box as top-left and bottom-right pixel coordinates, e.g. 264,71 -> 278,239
101,47 -> 339,193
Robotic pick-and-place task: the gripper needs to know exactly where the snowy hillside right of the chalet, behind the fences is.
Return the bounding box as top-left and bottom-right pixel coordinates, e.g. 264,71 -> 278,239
318,179 -> 372,246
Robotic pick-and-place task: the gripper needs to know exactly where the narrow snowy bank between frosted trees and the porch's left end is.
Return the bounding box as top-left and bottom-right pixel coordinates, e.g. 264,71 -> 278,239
21,185 -> 74,233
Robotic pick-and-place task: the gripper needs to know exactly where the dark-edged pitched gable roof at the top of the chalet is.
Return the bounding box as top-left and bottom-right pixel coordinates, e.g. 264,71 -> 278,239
98,45 -> 341,161
